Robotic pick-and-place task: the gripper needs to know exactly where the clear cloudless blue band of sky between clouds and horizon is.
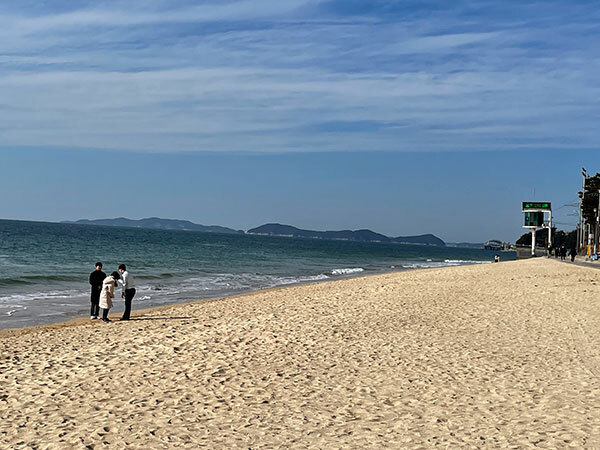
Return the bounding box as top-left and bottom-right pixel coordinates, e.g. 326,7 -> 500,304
0,149 -> 600,242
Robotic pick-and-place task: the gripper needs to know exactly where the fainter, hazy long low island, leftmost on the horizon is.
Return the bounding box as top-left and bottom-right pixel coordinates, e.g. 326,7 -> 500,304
61,217 -> 244,234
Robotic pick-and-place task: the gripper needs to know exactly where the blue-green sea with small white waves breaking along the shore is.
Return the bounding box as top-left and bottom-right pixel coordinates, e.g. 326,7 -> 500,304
0,220 -> 515,328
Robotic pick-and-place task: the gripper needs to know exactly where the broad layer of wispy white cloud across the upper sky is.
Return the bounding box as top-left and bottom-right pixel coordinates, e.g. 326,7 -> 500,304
0,0 -> 600,152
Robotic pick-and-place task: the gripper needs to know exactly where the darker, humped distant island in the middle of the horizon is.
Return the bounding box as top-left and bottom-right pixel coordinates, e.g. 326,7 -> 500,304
246,223 -> 446,247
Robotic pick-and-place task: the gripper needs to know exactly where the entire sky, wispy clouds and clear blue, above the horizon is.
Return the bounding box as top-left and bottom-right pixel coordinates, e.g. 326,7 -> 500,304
0,0 -> 600,242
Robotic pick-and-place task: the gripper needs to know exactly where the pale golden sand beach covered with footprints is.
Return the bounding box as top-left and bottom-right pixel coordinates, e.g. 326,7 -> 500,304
0,259 -> 600,449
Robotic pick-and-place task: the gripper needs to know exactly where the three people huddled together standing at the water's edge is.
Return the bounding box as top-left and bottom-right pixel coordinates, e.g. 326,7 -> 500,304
90,262 -> 135,322
